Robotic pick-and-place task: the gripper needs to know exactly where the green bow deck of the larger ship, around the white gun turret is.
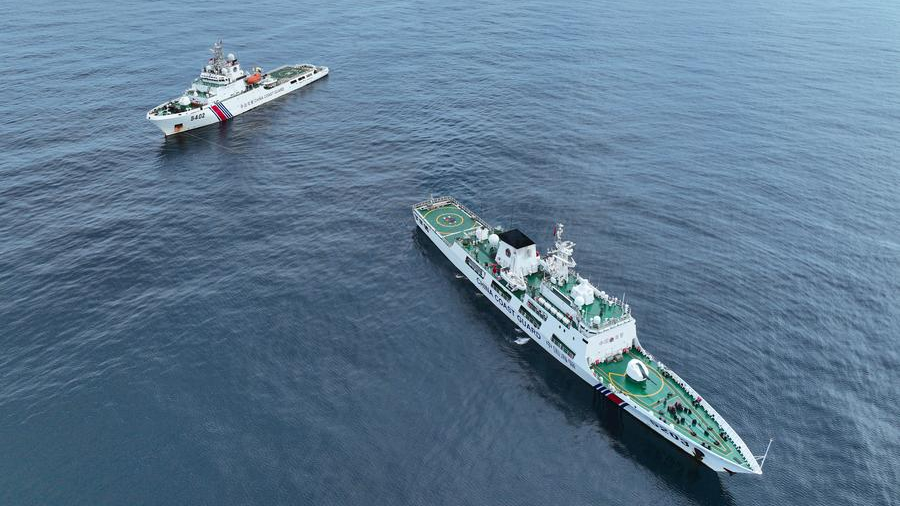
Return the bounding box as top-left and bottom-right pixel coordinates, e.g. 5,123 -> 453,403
592,348 -> 749,466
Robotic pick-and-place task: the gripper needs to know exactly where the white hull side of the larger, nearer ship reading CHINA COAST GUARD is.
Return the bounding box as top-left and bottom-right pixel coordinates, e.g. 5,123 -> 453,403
413,206 -> 761,474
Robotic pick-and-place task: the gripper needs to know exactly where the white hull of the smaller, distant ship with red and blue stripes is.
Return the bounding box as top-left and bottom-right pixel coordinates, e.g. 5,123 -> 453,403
147,67 -> 328,136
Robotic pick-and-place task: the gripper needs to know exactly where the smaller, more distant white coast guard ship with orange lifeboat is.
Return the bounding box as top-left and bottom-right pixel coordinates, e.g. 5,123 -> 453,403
147,41 -> 328,135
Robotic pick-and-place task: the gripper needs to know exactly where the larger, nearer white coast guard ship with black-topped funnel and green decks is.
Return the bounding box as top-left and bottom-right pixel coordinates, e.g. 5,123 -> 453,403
413,197 -> 771,474
